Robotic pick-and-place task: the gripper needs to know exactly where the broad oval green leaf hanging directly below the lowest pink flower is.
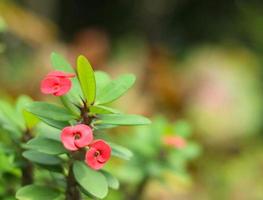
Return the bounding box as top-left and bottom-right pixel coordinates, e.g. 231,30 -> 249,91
73,161 -> 108,199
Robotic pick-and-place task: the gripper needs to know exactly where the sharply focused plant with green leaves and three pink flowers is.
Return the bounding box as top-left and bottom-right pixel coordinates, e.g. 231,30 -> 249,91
9,53 -> 150,200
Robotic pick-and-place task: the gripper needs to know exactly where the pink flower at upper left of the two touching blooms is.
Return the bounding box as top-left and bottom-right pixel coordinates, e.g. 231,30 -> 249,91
61,124 -> 93,151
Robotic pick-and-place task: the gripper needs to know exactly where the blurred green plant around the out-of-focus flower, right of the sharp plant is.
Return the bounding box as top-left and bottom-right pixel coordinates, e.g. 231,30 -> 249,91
104,116 -> 201,199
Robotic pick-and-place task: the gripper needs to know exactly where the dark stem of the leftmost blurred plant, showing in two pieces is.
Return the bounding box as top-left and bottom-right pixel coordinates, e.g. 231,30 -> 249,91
21,129 -> 34,186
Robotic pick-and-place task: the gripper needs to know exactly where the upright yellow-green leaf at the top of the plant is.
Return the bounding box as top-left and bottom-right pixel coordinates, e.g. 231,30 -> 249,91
77,55 -> 96,105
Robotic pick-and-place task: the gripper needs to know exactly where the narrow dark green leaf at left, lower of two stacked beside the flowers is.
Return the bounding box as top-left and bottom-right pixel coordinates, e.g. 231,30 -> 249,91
22,150 -> 62,165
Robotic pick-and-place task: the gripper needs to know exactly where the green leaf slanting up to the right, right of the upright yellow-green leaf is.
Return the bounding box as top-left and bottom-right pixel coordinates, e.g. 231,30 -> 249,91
96,74 -> 136,104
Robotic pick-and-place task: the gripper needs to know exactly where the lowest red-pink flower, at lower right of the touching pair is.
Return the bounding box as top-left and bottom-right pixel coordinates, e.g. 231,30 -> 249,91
85,140 -> 111,170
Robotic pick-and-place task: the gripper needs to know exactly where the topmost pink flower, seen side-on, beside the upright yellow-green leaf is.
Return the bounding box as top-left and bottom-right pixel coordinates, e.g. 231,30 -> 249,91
40,71 -> 75,96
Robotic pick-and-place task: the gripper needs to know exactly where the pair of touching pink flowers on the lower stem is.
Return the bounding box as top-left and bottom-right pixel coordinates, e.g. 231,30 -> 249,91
61,124 -> 111,170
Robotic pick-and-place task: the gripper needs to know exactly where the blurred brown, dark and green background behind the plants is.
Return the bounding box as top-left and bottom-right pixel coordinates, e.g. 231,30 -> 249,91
0,0 -> 263,200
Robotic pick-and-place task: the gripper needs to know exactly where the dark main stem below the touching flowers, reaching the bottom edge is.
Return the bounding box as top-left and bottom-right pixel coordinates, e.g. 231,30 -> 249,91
66,164 -> 81,200
